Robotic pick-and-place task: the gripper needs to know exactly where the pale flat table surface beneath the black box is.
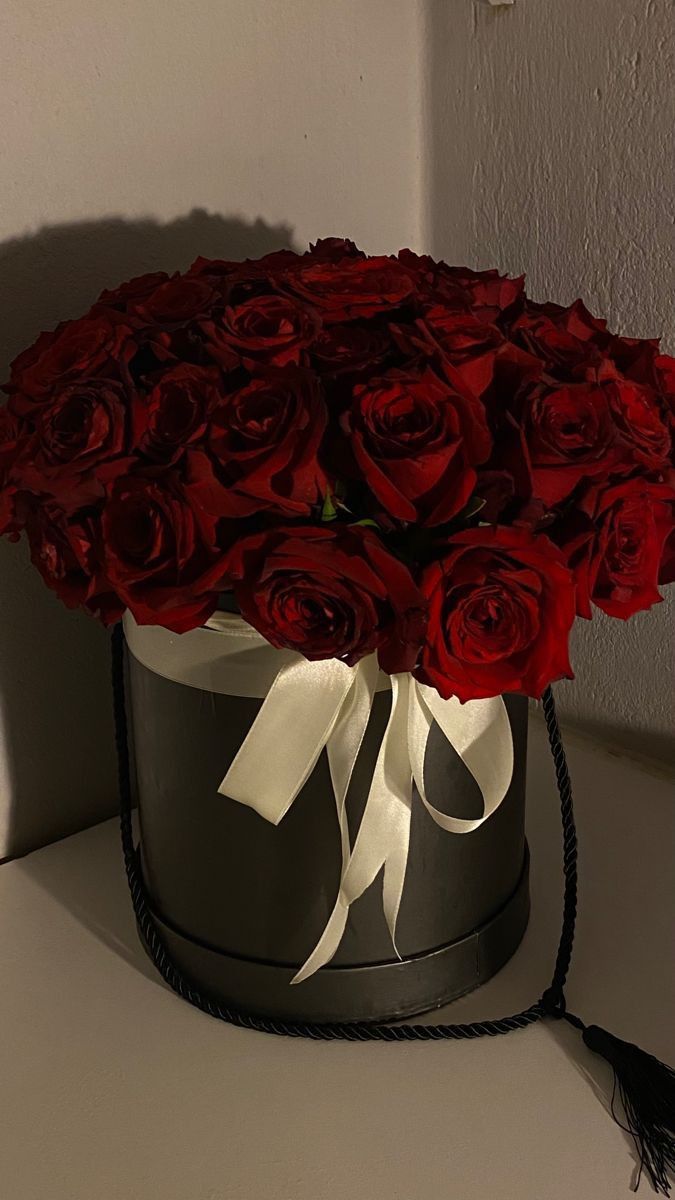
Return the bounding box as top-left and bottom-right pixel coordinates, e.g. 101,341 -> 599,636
0,719 -> 675,1200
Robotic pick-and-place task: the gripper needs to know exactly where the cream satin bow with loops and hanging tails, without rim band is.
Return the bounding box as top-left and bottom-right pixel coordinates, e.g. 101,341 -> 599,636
219,628 -> 513,983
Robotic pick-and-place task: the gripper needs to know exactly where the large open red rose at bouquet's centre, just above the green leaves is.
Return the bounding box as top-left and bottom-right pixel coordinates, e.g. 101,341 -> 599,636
341,367 -> 491,524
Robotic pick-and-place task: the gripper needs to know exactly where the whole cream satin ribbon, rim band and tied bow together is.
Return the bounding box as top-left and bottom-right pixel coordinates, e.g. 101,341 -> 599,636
124,613 -> 513,983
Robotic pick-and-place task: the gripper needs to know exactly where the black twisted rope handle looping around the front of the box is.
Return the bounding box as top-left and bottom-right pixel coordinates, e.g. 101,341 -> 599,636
112,624 -> 571,1042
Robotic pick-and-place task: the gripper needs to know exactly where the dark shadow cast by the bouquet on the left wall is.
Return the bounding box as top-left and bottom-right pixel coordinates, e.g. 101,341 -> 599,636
0,209 -> 292,859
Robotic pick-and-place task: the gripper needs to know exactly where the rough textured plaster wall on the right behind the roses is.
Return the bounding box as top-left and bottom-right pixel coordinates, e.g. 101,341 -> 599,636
424,0 -> 675,758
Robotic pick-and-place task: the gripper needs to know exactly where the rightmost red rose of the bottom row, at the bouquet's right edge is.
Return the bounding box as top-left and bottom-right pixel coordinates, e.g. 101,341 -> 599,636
551,479 -> 675,620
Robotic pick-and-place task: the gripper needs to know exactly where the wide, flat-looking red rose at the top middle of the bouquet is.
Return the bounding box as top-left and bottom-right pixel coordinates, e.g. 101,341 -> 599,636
281,258 -> 414,324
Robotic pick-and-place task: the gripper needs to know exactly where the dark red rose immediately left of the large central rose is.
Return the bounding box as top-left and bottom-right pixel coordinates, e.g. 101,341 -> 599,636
187,366 -> 327,517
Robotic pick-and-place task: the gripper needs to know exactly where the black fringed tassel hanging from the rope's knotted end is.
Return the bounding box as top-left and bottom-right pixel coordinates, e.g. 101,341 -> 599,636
583,1025 -> 675,1196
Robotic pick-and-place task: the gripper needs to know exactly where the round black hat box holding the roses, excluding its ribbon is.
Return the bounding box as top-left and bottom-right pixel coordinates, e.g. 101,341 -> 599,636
127,628 -> 530,1021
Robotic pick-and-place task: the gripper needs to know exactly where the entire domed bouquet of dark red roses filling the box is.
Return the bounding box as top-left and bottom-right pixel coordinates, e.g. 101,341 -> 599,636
0,239 -> 675,701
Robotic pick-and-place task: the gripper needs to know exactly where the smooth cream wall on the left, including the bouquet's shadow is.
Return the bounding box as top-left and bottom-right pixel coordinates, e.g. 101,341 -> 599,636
0,0 -> 420,857
